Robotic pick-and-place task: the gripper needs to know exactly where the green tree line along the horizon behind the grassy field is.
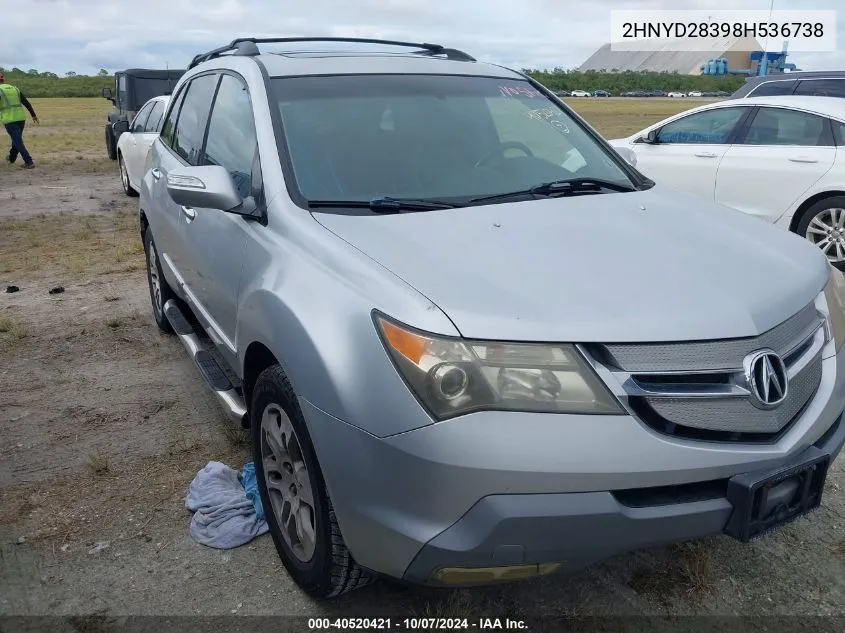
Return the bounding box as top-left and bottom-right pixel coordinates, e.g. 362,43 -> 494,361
0,68 -> 745,97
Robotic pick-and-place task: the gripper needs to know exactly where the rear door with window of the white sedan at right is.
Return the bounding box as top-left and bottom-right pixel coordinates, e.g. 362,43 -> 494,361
716,106 -> 836,222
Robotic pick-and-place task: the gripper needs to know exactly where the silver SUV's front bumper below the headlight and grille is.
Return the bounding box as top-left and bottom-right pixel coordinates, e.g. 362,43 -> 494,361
300,349 -> 845,584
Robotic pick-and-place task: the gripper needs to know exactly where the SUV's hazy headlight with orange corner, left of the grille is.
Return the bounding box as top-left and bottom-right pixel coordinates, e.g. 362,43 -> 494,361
375,315 -> 625,420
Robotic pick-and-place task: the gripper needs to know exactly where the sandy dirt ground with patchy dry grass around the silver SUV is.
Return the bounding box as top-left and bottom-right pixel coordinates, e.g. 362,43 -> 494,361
0,104 -> 845,630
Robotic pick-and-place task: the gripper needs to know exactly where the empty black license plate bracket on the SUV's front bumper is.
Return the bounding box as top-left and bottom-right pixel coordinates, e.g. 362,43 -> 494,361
725,447 -> 830,543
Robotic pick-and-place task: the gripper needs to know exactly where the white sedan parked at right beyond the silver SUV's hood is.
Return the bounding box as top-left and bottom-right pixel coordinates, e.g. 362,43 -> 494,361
610,96 -> 845,270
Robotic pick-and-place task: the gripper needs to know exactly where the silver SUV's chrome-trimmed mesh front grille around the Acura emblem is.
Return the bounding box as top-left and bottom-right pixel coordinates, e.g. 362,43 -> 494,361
586,303 -> 824,442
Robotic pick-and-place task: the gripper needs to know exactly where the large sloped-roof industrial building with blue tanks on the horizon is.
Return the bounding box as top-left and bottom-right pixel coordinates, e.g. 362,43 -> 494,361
578,38 -> 795,75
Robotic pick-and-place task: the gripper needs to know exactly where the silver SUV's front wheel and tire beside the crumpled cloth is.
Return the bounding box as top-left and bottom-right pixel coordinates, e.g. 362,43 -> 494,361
249,365 -> 374,598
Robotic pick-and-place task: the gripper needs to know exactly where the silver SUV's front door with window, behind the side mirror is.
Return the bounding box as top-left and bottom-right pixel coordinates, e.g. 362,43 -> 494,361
182,73 -> 260,354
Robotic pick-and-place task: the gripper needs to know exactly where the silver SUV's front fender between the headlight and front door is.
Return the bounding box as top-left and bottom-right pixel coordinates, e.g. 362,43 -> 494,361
235,217 -> 459,437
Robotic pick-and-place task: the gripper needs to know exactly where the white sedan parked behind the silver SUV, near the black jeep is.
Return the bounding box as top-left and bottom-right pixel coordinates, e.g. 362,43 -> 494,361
117,96 -> 170,197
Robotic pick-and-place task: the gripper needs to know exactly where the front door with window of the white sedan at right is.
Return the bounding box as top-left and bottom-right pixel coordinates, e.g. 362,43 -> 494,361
632,106 -> 750,200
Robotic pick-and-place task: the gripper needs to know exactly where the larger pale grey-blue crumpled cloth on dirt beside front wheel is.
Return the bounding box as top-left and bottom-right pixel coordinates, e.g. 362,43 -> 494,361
185,461 -> 268,549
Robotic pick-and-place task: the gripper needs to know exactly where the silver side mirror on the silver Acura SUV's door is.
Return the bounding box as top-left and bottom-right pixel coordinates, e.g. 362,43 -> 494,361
167,165 -> 243,211
